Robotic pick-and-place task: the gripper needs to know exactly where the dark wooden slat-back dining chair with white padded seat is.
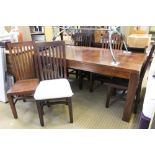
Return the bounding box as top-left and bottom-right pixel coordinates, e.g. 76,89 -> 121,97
34,41 -> 73,126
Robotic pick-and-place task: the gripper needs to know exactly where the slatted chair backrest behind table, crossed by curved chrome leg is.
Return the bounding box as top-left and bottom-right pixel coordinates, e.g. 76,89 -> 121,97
102,33 -> 123,50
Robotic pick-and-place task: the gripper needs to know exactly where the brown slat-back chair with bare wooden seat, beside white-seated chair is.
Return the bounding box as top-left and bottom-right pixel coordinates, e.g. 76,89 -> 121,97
7,41 -> 39,118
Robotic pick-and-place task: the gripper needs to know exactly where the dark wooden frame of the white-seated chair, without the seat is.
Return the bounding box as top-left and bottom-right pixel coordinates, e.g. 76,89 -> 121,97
35,41 -> 73,126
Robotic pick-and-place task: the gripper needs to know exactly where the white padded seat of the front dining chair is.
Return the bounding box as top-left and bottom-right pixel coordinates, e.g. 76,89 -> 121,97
34,79 -> 73,100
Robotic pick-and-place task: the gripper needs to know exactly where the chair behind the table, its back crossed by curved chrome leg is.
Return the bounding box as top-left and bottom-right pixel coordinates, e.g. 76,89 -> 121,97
89,32 -> 123,92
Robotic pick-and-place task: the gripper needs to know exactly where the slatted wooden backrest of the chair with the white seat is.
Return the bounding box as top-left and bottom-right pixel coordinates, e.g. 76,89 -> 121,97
35,41 -> 67,80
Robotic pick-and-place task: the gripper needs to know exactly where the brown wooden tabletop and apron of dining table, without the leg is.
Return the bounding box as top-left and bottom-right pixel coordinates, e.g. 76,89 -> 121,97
66,46 -> 147,79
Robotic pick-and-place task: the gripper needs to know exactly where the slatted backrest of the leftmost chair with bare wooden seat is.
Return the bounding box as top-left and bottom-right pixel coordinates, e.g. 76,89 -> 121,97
7,41 -> 36,81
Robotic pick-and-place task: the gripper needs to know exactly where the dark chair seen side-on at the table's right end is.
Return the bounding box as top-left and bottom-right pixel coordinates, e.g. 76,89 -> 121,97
104,44 -> 155,113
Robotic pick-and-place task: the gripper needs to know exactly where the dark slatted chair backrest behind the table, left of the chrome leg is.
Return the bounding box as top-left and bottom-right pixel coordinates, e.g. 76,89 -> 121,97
73,32 -> 92,47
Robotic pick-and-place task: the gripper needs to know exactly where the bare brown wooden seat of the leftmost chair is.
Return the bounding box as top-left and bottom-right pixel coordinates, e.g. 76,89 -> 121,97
7,79 -> 39,95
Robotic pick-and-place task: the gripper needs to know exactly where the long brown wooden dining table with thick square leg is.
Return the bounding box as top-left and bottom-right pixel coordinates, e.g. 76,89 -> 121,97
66,46 -> 147,122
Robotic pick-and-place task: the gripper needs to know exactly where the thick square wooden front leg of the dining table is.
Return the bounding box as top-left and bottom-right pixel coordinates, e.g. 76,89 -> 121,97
122,73 -> 139,122
